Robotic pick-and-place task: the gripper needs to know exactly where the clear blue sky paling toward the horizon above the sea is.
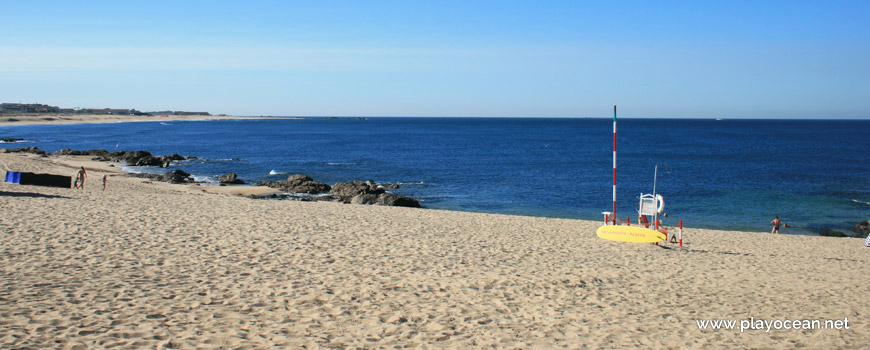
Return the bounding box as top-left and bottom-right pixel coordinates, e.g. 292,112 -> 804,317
0,0 -> 870,118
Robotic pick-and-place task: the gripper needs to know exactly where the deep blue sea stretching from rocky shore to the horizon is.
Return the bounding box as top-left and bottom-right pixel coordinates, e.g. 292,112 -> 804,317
0,118 -> 870,234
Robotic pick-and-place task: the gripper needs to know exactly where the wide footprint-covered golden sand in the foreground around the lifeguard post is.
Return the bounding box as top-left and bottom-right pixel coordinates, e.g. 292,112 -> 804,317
0,154 -> 870,349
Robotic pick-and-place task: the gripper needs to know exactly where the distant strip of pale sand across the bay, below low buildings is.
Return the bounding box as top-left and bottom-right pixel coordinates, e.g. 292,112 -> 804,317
0,114 -> 296,126
